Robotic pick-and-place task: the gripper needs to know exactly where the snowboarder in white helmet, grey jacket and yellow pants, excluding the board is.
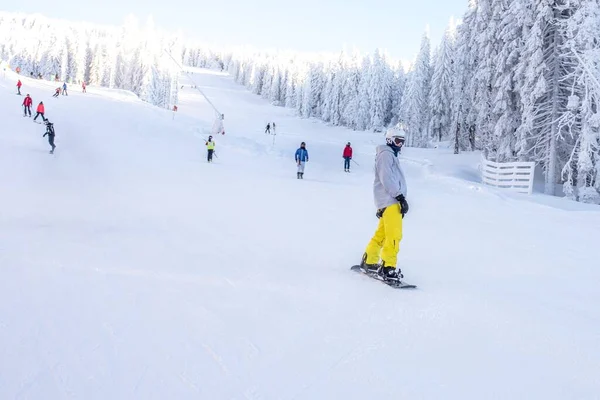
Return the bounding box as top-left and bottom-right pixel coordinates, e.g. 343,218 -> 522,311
361,127 -> 408,281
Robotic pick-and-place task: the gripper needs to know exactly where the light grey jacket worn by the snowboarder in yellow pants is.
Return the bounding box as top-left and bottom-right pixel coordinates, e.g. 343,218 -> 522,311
373,144 -> 407,209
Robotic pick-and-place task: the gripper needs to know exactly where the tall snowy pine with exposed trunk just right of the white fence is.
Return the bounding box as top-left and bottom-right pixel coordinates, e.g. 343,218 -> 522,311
519,0 -> 577,194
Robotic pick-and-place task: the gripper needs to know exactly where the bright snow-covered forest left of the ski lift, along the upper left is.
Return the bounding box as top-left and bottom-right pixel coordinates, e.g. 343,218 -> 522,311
0,12 -> 183,108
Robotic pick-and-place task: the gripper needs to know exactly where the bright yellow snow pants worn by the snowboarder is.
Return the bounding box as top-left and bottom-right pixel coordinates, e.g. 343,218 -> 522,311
366,203 -> 402,267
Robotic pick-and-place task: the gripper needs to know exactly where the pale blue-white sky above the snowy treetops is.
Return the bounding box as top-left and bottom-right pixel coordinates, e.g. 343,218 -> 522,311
3,0 -> 468,60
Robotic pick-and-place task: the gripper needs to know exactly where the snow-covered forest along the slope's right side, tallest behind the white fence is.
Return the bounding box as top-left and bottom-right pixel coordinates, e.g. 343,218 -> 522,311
185,0 -> 600,203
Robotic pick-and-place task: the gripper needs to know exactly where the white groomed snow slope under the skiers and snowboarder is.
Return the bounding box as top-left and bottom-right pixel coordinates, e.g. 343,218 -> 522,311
0,71 -> 600,400
